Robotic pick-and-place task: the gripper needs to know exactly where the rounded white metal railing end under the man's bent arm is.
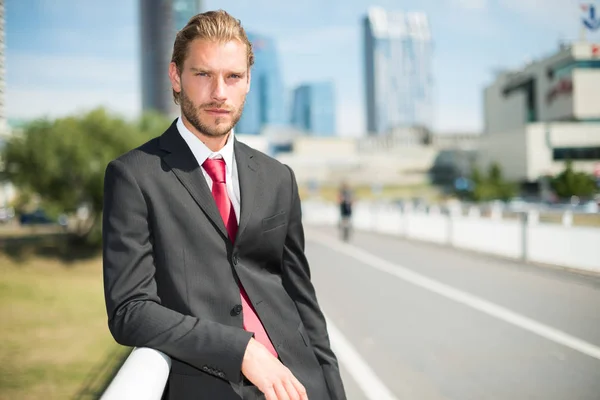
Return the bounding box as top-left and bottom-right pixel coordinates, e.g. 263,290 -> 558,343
100,347 -> 171,400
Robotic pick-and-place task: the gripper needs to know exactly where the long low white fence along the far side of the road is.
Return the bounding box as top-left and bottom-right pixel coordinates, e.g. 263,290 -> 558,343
302,200 -> 600,272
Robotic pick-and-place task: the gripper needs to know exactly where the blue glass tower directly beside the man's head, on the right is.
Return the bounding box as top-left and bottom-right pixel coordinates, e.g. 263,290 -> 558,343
235,33 -> 286,135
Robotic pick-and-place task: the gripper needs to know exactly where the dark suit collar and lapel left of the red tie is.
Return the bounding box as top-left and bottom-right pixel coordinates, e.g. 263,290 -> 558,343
160,122 -> 228,237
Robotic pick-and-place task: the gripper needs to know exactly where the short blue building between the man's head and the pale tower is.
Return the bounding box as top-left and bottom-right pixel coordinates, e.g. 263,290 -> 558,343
291,82 -> 335,136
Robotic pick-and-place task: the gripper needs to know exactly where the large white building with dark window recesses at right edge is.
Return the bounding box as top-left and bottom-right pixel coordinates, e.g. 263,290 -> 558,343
479,43 -> 600,182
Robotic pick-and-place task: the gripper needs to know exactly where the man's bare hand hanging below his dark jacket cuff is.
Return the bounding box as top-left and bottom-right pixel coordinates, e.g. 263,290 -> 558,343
242,338 -> 308,400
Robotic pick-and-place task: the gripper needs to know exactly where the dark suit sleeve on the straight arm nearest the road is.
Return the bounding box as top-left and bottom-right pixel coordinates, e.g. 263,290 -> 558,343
282,165 -> 346,400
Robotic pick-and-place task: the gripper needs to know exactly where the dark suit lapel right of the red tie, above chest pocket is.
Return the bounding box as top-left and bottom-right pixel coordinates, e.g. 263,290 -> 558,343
233,139 -> 261,243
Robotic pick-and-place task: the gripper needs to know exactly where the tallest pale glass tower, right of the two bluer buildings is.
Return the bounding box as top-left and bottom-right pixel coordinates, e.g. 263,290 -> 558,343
363,7 -> 433,135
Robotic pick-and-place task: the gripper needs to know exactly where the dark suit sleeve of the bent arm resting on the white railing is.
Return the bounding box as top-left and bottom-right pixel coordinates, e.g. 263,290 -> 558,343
102,160 -> 251,382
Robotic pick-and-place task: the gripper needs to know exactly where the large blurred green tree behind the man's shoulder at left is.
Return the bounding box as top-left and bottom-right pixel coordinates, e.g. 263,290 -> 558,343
2,108 -> 169,241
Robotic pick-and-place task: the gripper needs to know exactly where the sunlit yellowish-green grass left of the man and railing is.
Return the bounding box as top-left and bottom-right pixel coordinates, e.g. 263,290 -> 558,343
0,255 -> 128,400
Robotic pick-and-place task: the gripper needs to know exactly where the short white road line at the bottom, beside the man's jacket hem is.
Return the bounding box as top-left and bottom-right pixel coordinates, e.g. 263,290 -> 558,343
326,317 -> 397,400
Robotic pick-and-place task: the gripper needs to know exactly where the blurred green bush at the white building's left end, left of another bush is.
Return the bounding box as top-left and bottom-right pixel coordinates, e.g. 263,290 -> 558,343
470,163 -> 517,201
